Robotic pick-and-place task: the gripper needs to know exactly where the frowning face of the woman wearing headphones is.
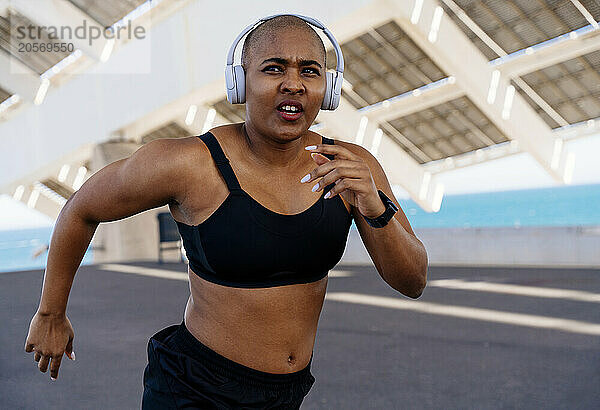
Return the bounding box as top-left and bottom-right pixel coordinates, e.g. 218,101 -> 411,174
246,29 -> 326,140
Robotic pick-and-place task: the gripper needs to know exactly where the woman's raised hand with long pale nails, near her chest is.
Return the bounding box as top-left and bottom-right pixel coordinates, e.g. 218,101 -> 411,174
304,144 -> 385,218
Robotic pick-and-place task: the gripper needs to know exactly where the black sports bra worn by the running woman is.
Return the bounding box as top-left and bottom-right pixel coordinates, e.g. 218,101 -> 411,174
176,131 -> 352,288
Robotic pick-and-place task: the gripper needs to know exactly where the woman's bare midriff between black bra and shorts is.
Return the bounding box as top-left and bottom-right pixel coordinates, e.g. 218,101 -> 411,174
185,268 -> 327,373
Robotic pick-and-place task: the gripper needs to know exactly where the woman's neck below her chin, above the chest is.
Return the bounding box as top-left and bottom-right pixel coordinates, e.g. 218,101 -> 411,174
241,123 -> 320,169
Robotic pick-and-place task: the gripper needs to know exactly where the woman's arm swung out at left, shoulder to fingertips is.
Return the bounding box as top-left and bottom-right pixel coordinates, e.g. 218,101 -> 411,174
25,139 -> 191,378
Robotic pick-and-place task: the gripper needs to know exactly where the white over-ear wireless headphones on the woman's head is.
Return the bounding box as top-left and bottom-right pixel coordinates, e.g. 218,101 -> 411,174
225,13 -> 344,111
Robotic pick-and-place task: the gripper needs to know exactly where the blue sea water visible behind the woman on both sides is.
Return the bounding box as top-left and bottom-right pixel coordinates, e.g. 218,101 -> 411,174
0,184 -> 600,272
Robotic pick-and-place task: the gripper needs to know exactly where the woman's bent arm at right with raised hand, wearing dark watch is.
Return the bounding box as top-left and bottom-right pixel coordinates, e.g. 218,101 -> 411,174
307,140 -> 428,299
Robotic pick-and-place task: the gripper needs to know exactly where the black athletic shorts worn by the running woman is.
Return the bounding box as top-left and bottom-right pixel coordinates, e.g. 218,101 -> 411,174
142,322 -> 315,410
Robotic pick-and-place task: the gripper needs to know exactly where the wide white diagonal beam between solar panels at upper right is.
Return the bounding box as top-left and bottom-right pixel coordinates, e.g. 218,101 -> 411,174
388,0 -> 574,182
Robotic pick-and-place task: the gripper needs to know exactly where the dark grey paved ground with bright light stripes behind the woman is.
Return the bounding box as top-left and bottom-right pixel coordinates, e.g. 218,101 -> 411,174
0,263 -> 600,409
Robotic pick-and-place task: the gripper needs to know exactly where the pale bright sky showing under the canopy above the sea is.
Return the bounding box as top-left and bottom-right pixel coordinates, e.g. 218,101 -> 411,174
0,134 -> 600,230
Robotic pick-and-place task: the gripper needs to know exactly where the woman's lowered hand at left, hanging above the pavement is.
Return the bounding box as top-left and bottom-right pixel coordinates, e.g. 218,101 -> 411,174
25,311 -> 75,380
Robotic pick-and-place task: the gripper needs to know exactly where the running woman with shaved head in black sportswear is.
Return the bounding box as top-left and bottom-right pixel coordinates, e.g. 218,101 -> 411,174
25,15 -> 427,409
